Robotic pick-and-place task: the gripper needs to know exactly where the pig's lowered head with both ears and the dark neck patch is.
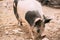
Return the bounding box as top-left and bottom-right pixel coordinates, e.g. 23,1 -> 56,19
25,11 -> 51,37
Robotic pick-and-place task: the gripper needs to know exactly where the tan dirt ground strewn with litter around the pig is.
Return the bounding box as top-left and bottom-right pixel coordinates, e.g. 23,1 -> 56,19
0,0 -> 60,40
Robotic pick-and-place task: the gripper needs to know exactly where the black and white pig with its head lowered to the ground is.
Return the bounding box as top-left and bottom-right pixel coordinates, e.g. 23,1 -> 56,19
13,0 -> 50,38
